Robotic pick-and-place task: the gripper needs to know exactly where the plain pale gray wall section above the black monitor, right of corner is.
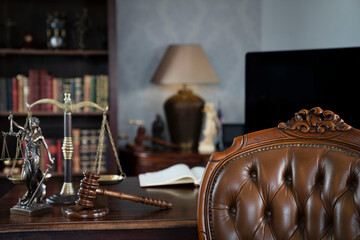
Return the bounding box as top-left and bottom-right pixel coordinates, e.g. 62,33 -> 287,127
261,0 -> 360,50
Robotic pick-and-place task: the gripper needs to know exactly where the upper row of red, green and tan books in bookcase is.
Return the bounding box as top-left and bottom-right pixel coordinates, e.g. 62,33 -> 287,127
0,69 -> 109,112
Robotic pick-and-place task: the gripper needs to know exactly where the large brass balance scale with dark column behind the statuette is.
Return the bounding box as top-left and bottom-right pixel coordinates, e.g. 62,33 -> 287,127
0,93 -> 126,204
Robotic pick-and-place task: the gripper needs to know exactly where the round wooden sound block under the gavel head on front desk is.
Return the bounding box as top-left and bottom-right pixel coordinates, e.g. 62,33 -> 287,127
64,205 -> 109,219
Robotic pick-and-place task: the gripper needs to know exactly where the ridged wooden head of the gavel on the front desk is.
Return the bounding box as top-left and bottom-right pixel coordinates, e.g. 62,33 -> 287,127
75,171 -> 100,208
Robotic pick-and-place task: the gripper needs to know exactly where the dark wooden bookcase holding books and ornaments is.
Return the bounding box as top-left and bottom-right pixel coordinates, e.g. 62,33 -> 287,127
0,0 -> 118,174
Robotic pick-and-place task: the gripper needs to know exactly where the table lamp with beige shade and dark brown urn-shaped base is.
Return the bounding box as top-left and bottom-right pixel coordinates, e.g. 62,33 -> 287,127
151,45 -> 219,151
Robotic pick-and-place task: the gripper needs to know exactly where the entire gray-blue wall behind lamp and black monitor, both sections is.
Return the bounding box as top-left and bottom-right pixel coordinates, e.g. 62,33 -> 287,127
117,0 -> 360,141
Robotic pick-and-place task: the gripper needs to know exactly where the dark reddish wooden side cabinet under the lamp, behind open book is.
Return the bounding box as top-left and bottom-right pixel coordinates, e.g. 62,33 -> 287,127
120,149 -> 210,176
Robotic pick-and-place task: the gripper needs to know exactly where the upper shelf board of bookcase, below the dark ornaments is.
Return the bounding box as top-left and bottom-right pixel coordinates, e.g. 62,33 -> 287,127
0,48 -> 108,57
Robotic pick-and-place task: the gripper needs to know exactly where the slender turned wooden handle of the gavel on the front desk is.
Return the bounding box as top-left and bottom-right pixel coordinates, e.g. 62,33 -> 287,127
96,188 -> 172,208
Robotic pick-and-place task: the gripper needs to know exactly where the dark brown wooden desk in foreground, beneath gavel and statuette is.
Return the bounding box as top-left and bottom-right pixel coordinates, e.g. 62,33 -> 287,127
0,177 -> 198,240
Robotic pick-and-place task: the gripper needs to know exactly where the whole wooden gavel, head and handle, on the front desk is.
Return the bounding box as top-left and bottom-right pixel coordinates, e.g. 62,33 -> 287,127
75,171 -> 172,208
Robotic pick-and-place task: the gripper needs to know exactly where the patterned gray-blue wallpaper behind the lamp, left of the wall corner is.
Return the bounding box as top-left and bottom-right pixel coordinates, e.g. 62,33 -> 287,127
116,0 -> 261,140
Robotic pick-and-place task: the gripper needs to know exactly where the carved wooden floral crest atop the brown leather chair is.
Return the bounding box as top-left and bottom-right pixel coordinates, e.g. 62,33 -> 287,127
278,107 -> 351,133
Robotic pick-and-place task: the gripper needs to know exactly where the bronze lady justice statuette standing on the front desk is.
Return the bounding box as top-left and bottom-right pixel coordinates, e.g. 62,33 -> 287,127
9,114 -> 54,216
